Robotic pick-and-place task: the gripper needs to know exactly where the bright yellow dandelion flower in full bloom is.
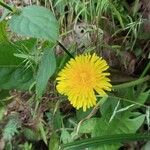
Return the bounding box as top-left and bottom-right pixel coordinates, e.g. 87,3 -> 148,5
56,53 -> 112,111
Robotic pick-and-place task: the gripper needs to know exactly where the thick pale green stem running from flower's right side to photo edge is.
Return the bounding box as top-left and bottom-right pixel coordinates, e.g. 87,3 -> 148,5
113,75 -> 150,89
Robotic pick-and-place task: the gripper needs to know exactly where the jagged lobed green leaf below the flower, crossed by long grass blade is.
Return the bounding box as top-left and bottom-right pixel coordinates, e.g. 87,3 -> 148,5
79,99 -> 145,150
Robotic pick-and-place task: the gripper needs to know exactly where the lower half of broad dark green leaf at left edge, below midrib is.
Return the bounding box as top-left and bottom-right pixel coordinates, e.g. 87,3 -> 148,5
0,67 -> 35,91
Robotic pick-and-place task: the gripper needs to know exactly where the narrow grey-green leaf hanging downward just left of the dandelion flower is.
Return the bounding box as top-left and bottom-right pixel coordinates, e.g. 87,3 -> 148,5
36,48 -> 56,98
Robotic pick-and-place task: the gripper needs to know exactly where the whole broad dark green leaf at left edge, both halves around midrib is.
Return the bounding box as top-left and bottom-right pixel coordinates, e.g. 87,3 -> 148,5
0,39 -> 35,90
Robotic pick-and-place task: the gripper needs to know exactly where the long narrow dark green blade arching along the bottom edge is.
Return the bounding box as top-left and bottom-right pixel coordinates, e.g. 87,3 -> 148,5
62,134 -> 150,150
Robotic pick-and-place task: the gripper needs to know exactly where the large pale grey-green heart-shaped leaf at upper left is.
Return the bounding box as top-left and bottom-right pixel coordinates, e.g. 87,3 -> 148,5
9,6 -> 59,42
